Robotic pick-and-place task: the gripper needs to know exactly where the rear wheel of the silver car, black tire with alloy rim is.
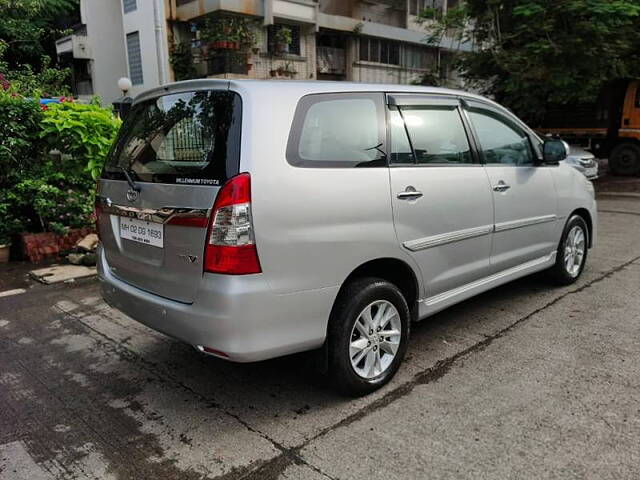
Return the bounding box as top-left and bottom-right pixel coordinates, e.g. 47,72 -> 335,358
328,277 -> 410,396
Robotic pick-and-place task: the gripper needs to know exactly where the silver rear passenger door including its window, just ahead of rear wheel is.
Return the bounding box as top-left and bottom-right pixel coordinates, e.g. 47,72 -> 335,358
389,95 -> 493,297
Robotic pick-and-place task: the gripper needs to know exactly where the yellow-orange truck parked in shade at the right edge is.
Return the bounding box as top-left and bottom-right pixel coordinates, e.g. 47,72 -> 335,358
538,80 -> 640,175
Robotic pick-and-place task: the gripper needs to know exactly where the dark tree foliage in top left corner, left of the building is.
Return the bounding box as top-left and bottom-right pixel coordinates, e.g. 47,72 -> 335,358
0,0 -> 79,73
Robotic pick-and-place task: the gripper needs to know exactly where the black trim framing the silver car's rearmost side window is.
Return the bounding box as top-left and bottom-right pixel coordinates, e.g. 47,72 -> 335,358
285,91 -> 389,169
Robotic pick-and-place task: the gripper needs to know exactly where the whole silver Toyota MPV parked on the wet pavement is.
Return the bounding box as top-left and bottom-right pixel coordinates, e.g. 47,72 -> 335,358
96,80 -> 596,394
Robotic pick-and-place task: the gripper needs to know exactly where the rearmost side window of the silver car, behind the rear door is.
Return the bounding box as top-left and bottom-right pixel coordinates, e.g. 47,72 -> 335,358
287,93 -> 387,168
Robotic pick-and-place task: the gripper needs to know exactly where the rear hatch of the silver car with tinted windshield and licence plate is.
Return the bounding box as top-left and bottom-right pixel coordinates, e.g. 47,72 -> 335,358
96,89 -> 242,303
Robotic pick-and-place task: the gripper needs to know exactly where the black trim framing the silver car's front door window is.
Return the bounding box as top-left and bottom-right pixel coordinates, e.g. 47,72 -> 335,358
460,97 -> 543,168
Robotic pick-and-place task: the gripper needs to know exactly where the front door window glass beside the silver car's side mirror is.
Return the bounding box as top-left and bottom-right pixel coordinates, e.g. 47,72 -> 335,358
469,110 -> 534,166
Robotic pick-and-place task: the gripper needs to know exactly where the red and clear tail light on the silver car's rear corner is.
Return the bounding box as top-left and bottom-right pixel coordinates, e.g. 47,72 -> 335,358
204,173 -> 262,275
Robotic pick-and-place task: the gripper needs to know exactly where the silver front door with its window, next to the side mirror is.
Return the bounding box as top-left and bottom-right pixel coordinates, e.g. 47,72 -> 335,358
467,102 -> 559,272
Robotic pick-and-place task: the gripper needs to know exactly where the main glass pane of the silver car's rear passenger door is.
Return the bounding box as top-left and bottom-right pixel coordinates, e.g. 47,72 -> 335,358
401,106 -> 473,164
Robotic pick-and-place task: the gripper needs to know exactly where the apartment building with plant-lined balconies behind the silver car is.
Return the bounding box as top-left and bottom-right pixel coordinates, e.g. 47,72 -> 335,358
57,0 -> 472,103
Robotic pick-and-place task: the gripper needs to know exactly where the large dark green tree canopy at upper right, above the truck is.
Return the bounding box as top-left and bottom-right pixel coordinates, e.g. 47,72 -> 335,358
422,0 -> 640,122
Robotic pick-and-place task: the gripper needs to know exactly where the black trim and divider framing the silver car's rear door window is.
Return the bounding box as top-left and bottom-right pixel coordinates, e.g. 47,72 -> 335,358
386,93 -> 482,168
